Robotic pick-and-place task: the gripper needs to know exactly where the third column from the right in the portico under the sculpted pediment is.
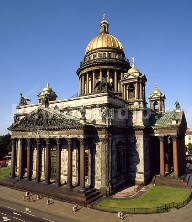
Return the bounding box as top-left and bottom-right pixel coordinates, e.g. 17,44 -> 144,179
56,138 -> 61,186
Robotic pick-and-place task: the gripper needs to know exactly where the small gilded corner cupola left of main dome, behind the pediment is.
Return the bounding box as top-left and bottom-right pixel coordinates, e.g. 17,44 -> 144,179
37,83 -> 57,103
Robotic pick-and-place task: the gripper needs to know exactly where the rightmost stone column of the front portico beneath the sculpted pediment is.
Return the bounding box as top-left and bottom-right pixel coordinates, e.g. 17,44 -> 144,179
80,139 -> 85,191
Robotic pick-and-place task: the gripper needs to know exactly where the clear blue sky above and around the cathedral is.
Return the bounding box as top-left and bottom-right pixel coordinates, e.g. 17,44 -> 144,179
0,0 -> 192,135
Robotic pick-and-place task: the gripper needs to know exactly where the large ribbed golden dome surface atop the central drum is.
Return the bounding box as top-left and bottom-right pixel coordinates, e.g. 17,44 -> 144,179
86,33 -> 123,53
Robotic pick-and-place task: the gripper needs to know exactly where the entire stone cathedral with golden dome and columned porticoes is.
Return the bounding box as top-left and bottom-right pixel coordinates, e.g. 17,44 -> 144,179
9,17 -> 187,198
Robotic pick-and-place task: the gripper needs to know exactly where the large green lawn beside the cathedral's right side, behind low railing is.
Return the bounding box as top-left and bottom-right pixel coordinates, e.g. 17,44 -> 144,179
96,186 -> 191,211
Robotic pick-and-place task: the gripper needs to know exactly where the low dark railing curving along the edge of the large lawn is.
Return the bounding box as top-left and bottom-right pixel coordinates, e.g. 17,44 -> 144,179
93,194 -> 192,214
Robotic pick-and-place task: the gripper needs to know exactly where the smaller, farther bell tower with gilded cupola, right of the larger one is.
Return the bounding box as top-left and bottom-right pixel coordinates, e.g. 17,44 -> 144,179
149,85 -> 166,112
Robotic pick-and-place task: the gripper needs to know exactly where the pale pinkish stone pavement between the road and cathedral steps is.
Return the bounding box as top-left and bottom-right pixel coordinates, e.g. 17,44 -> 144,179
0,186 -> 192,222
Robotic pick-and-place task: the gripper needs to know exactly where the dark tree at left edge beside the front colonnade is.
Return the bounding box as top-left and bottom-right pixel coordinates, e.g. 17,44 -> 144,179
0,133 -> 11,156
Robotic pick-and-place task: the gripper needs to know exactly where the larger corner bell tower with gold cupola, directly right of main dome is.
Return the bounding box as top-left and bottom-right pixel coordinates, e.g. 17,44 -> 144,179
121,58 -> 147,108
